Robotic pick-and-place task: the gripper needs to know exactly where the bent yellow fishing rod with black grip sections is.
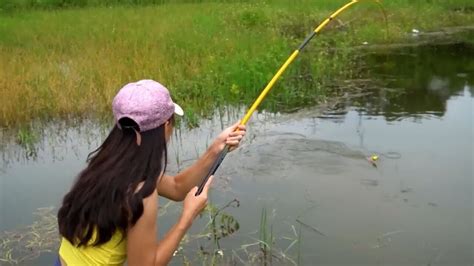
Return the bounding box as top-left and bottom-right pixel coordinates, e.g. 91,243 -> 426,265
195,0 -> 387,196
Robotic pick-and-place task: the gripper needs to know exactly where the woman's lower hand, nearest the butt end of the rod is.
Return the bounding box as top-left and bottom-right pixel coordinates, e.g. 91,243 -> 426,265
183,176 -> 214,223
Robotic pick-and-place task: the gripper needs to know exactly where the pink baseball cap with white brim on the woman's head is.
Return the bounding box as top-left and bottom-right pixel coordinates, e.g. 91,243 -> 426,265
112,79 -> 184,132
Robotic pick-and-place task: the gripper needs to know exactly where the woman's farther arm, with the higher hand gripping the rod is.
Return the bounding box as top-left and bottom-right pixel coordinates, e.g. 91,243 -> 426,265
157,121 -> 246,201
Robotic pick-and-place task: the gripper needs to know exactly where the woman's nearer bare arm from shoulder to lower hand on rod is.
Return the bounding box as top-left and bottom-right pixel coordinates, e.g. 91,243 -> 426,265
127,178 -> 212,266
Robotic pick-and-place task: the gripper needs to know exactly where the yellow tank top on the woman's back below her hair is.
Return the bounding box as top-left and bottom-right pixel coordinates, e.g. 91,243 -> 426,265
59,231 -> 127,266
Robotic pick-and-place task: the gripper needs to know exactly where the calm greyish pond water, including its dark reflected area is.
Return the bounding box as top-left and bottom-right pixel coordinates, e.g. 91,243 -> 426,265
0,42 -> 474,265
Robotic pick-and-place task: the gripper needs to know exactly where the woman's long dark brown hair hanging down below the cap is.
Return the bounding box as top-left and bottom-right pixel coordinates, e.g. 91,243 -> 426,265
58,118 -> 167,246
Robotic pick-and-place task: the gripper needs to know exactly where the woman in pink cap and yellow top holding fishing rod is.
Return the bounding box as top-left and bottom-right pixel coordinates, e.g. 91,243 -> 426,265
57,80 -> 245,266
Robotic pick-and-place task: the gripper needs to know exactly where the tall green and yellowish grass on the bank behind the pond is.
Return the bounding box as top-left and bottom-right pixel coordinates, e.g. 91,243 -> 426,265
0,0 -> 474,127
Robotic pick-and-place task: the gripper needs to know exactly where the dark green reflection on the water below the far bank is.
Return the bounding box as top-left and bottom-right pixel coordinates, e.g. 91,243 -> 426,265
326,43 -> 474,121
